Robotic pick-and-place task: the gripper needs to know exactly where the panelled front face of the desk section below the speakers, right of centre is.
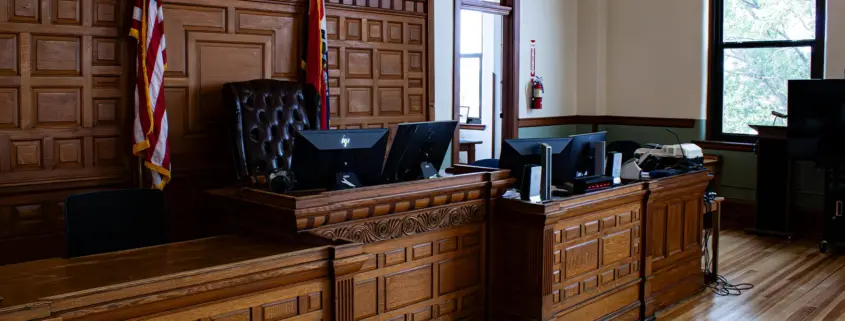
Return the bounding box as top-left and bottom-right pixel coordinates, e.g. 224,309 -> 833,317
543,203 -> 642,311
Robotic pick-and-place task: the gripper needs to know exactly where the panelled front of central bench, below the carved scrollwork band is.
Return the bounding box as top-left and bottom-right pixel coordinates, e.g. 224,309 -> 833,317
338,223 -> 486,320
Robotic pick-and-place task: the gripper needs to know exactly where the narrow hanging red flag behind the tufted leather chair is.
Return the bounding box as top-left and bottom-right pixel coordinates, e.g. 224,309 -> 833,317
302,0 -> 330,129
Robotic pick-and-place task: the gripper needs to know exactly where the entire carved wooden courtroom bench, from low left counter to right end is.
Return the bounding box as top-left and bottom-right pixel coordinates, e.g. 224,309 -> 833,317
0,155 -> 710,320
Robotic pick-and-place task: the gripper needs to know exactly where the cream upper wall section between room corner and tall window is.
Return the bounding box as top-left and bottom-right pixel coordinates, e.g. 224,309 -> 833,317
605,0 -> 708,119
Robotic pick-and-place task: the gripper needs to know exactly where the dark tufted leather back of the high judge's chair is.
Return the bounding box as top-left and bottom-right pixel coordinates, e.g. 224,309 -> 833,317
223,79 -> 320,182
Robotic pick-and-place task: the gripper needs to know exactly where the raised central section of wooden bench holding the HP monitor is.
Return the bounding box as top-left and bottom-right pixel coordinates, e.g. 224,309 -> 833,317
204,167 -> 513,321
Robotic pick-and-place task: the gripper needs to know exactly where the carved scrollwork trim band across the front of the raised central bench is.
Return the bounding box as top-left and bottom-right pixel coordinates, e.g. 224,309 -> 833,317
314,204 -> 484,243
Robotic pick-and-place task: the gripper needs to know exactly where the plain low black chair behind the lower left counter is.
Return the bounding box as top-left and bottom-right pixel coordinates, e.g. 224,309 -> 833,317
65,189 -> 168,257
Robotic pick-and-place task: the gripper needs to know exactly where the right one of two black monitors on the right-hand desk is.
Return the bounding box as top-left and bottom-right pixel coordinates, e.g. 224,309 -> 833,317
555,132 -> 607,180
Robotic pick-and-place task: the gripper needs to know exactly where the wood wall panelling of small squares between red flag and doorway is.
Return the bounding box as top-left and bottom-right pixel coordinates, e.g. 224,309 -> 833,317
327,6 -> 433,129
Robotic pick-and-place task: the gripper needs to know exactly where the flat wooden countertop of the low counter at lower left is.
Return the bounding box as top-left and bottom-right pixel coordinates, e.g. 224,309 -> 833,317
0,235 -> 329,310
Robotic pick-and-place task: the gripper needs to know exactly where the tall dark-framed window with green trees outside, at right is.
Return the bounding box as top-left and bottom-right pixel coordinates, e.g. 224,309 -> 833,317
708,0 -> 825,141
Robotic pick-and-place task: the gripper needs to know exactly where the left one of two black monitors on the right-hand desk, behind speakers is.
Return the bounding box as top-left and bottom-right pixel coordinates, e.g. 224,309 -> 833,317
499,138 -> 572,186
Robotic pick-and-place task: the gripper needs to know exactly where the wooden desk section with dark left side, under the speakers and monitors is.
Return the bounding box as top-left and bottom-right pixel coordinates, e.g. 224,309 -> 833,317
490,183 -> 646,320
